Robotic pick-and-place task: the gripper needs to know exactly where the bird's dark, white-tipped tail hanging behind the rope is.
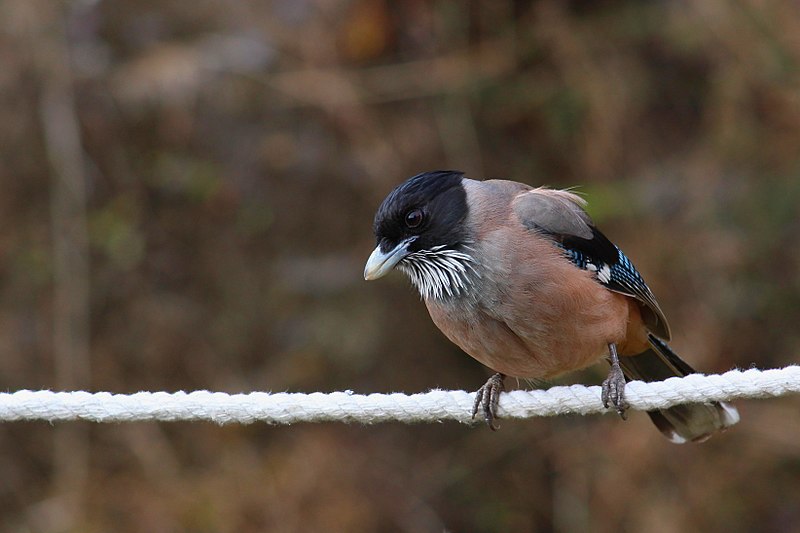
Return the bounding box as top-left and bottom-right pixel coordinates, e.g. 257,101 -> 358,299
620,335 -> 739,443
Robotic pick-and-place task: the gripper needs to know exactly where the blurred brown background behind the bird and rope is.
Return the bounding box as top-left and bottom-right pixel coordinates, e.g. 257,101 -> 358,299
0,0 -> 800,533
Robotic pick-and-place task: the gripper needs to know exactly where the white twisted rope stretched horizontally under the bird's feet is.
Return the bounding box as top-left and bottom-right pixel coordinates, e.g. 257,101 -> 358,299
0,366 -> 800,424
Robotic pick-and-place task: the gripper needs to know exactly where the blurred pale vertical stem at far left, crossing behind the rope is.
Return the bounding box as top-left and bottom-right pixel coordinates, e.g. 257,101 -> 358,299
30,2 -> 90,530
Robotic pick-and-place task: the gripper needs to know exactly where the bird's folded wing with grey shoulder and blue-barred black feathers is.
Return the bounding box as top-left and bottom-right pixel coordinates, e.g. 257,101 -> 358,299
512,188 -> 670,340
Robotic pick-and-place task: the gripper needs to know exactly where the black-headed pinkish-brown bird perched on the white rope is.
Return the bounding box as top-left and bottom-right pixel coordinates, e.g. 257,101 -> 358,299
364,170 -> 739,443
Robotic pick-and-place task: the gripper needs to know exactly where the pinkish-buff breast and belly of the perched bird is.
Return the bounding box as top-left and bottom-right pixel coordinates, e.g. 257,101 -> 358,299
425,234 -> 631,378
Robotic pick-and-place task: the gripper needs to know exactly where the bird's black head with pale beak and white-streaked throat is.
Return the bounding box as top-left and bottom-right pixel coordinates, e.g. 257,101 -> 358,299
364,170 -> 477,299
